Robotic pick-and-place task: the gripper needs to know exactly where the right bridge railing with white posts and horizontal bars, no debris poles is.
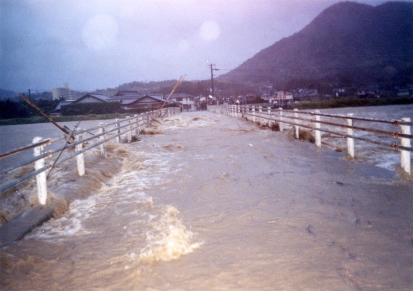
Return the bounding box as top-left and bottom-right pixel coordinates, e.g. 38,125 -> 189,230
208,105 -> 413,175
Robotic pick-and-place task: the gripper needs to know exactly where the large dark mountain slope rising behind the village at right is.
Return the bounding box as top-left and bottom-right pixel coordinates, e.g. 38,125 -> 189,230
218,2 -> 413,87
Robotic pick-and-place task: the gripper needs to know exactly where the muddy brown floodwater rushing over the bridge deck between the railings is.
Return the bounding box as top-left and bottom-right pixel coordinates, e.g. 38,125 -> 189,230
0,106 -> 413,291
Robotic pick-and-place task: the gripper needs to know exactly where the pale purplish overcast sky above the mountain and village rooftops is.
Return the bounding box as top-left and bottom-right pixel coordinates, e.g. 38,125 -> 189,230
0,0 -> 400,92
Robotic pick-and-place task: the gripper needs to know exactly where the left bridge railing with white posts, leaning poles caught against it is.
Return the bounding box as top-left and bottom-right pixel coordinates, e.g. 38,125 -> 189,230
0,107 -> 181,205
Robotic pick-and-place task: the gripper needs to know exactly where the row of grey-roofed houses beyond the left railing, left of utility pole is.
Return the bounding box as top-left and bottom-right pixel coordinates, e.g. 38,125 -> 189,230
55,91 -> 199,113
